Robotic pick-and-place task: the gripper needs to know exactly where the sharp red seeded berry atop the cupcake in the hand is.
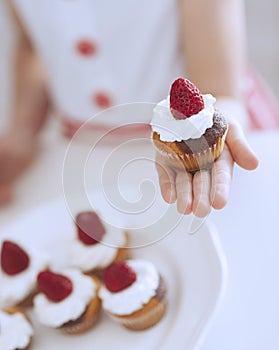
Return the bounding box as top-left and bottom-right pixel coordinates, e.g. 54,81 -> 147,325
170,78 -> 204,119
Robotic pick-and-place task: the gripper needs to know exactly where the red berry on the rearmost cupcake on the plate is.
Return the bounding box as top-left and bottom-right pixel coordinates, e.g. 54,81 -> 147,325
76,211 -> 106,245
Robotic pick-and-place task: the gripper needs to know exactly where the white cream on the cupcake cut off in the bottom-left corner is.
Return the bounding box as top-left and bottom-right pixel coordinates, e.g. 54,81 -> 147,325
0,311 -> 34,350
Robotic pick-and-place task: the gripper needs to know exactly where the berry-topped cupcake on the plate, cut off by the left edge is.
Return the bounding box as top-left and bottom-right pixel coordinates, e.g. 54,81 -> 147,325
0,240 -> 47,308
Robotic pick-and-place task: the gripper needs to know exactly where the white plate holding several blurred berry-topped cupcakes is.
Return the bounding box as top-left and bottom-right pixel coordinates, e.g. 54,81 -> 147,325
0,183 -> 227,350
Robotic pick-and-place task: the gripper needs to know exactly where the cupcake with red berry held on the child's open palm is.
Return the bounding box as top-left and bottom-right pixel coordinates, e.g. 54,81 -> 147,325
151,78 -> 228,172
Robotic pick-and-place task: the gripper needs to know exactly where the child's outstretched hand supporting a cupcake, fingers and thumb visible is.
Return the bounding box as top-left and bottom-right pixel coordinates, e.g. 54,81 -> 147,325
156,122 -> 258,217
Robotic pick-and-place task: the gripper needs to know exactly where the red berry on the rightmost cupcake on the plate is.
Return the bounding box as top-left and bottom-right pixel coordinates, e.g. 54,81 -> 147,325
103,261 -> 137,293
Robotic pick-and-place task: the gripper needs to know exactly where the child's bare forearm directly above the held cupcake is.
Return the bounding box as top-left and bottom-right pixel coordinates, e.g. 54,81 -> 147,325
181,0 -> 246,98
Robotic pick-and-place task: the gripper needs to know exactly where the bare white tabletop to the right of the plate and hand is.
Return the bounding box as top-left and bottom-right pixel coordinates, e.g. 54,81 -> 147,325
202,132 -> 279,350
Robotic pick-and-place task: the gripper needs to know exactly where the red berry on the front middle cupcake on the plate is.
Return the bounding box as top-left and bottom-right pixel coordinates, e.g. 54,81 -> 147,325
37,270 -> 73,303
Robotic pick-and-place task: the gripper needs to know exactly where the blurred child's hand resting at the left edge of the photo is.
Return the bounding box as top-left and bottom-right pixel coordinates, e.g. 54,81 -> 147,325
0,130 -> 37,205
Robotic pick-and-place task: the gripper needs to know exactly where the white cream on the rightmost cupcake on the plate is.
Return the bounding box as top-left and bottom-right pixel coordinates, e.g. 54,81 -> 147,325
99,259 -> 160,315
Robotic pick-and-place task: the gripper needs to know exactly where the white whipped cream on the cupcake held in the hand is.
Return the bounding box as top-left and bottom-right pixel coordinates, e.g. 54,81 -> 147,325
151,94 -> 216,142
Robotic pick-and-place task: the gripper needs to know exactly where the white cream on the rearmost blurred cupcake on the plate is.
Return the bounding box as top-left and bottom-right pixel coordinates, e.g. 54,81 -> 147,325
68,227 -> 126,272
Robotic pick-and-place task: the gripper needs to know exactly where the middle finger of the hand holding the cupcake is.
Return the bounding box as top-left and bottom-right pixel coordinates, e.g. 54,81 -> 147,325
193,170 -> 211,218
